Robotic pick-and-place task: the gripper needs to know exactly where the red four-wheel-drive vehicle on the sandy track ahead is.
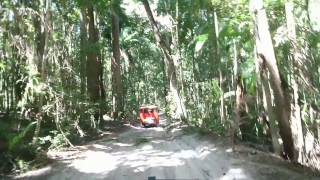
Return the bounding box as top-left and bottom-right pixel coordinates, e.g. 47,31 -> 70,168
139,106 -> 160,127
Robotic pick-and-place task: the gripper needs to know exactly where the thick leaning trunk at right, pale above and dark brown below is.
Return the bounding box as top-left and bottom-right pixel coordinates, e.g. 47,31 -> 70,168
251,0 -> 294,160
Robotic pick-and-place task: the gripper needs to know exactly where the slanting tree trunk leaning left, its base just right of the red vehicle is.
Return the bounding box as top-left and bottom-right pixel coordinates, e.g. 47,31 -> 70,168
142,0 -> 187,120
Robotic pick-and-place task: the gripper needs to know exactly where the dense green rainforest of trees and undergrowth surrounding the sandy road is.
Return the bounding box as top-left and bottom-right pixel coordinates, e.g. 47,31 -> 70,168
0,0 -> 320,173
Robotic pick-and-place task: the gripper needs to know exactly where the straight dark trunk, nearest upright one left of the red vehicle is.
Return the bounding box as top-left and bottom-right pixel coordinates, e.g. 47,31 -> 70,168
111,8 -> 123,119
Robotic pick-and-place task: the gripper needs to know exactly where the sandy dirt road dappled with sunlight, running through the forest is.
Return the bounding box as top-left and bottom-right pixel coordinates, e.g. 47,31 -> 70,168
16,118 -> 320,180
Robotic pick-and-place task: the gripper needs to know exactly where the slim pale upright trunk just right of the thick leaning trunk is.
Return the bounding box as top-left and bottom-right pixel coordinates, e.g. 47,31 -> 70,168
285,1 -> 304,163
